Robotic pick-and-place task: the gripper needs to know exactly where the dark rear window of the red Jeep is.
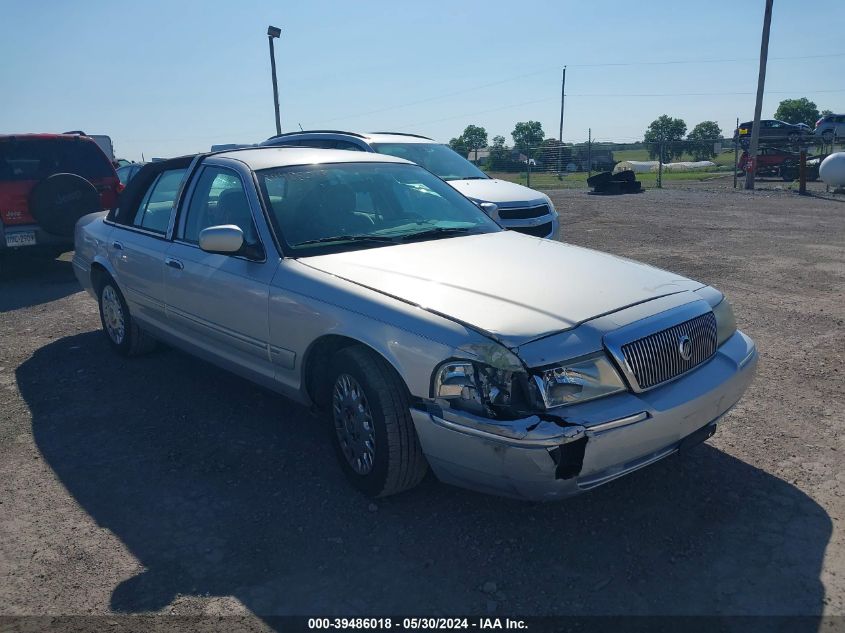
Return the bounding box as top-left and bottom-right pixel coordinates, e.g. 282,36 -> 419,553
0,138 -> 114,181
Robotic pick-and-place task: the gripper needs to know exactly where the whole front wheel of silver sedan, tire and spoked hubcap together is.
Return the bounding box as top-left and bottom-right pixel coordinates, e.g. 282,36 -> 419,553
325,346 -> 428,497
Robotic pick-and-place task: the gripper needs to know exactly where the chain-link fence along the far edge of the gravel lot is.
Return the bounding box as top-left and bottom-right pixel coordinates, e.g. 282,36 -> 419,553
468,135 -> 845,189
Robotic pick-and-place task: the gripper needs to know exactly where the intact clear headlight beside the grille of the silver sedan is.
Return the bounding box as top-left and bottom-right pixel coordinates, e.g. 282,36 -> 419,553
534,353 -> 626,409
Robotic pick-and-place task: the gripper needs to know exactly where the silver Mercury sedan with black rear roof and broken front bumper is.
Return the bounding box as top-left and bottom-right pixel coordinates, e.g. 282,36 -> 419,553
73,147 -> 757,499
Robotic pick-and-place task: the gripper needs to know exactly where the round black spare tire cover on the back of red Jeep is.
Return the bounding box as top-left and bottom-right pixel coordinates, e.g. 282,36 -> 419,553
29,174 -> 102,237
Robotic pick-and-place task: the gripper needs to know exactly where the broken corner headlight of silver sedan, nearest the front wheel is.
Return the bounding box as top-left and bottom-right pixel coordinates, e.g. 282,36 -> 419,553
433,360 -> 527,415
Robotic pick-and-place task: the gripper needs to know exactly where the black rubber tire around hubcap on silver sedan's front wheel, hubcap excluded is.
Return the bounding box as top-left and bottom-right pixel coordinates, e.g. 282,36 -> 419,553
325,346 -> 428,497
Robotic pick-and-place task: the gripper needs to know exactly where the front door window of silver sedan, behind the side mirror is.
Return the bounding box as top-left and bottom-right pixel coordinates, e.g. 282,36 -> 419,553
182,167 -> 258,244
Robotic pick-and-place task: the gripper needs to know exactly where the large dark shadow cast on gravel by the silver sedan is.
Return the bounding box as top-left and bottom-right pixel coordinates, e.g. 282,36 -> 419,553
17,332 -> 831,630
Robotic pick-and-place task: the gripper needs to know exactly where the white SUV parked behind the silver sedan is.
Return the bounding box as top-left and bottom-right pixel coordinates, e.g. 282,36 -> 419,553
261,130 -> 559,238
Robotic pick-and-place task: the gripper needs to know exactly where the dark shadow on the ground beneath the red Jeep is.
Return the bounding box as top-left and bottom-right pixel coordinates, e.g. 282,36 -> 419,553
0,253 -> 80,312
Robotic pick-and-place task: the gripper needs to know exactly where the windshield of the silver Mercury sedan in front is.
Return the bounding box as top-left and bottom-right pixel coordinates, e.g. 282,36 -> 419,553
257,163 -> 502,257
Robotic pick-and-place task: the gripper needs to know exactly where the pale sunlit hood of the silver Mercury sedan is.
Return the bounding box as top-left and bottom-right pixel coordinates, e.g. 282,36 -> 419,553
299,231 -> 702,348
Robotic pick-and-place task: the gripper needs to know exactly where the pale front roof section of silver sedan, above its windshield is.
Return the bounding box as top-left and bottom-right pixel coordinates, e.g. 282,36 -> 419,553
211,145 -> 413,171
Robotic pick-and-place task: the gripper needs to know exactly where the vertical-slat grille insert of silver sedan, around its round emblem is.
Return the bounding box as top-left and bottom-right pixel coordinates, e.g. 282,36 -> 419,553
622,312 -> 716,389
